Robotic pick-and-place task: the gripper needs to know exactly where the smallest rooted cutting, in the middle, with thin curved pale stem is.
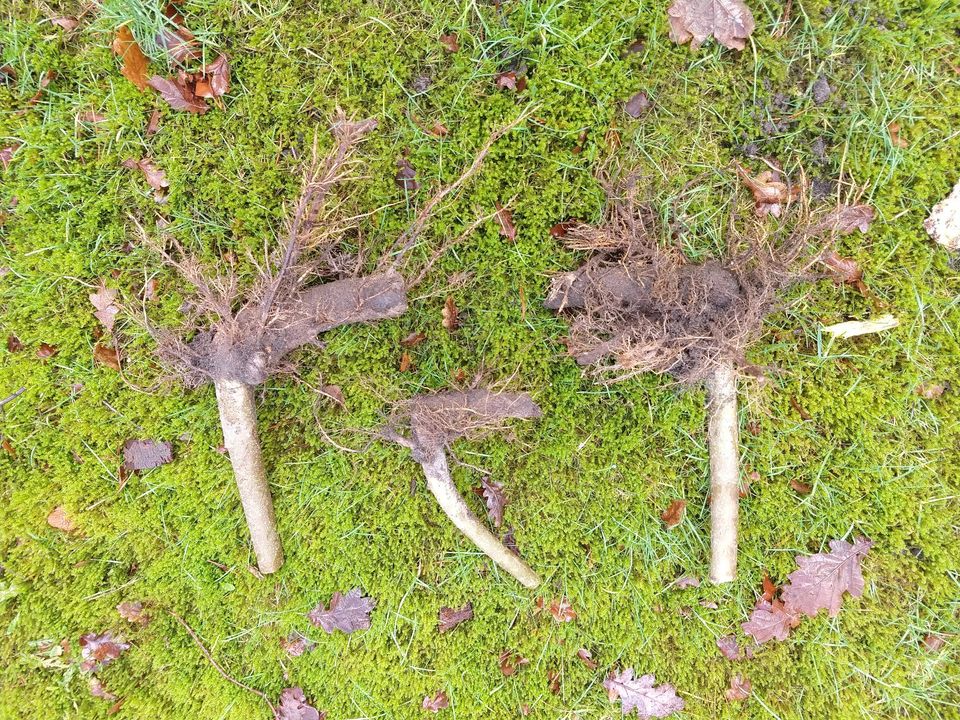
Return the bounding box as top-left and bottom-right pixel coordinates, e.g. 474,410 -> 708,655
384,390 -> 541,589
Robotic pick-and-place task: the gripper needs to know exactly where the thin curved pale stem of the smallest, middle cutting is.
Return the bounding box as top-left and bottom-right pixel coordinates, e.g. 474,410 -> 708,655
421,450 -> 540,590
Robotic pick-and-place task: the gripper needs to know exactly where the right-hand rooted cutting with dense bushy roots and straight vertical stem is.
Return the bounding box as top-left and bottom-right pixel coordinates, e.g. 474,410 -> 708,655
544,170 -> 864,583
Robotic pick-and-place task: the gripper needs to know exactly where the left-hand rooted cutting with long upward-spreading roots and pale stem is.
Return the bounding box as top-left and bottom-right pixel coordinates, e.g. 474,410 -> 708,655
151,110 -> 526,573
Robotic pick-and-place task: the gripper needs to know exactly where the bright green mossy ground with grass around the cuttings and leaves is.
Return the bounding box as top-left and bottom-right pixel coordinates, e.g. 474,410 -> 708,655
0,0 -> 960,719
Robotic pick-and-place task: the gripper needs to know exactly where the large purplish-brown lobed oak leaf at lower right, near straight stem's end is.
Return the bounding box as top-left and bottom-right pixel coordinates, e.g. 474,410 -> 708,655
781,538 -> 873,617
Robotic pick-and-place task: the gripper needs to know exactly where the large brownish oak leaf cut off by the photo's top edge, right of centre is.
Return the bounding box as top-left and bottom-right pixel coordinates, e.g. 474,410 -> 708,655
667,0 -> 755,50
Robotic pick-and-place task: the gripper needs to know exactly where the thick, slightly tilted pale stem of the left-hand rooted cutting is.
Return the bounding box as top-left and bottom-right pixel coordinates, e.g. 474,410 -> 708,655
214,380 -> 283,575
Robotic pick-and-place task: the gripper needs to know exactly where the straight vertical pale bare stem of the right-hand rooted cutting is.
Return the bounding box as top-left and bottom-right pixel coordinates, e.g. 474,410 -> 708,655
707,363 -> 740,584
